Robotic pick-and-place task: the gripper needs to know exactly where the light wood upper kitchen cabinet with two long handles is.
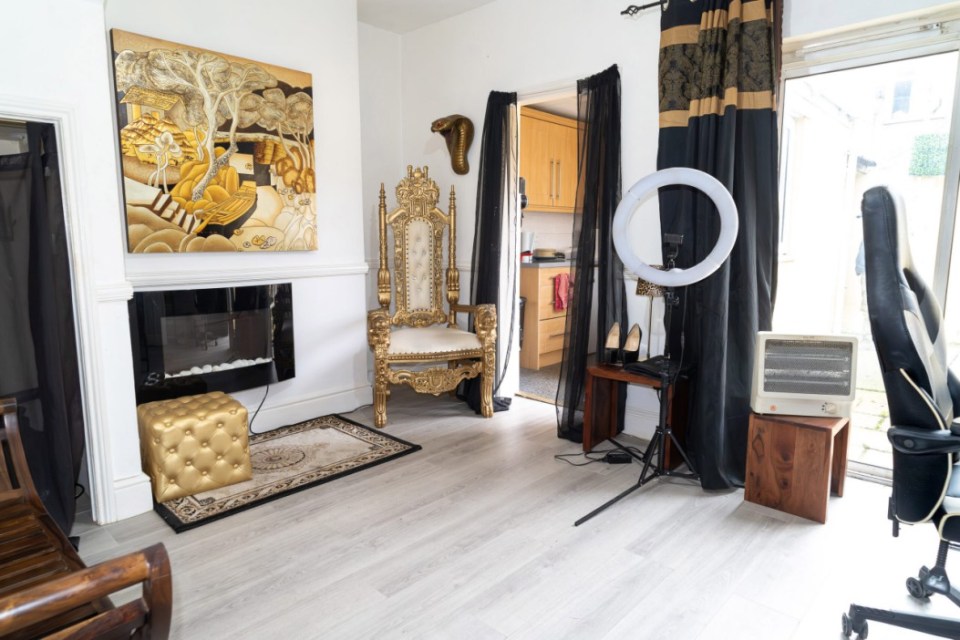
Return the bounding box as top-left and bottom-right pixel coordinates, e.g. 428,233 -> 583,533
520,107 -> 579,213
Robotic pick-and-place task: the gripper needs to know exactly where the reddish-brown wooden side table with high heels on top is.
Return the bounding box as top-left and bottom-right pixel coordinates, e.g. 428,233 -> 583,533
583,364 -> 687,469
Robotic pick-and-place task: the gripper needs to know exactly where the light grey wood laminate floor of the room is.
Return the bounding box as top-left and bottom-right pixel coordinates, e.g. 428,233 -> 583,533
75,388 -> 960,640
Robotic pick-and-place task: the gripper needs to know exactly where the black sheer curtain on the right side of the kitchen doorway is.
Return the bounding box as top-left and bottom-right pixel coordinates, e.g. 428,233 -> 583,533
557,65 -> 627,442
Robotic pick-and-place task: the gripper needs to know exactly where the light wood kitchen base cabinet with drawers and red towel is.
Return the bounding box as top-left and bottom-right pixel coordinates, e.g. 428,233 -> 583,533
520,266 -> 570,370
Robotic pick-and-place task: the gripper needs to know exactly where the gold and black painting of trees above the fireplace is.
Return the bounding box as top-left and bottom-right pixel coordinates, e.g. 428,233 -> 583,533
112,29 -> 317,253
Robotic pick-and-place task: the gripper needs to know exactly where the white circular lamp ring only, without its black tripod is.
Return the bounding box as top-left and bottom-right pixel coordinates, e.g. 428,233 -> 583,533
613,167 -> 740,287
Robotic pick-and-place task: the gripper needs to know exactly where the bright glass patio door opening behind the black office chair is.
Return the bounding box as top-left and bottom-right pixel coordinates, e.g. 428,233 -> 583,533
773,50 -> 960,475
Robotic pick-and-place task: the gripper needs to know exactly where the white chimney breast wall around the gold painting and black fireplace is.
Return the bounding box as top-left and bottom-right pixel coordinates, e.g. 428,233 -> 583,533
106,0 -> 370,516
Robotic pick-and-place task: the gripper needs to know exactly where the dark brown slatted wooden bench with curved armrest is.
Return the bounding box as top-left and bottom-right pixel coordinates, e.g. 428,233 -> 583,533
0,400 -> 172,639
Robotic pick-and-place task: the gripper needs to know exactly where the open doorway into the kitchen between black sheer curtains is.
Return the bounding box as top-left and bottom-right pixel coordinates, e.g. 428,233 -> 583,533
518,90 -> 580,404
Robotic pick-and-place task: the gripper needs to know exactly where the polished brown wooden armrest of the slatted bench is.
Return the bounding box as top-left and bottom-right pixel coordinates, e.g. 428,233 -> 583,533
0,544 -> 173,640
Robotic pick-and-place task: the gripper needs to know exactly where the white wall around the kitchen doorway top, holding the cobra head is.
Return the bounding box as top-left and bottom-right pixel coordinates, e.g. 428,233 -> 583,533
402,0 -> 659,249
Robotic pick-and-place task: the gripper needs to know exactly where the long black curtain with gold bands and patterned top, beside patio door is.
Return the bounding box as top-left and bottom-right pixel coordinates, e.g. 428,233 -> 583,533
657,0 -> 782,489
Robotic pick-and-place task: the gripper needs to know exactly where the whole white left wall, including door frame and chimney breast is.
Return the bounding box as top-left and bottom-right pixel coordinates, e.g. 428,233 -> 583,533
0,0 -> 370,522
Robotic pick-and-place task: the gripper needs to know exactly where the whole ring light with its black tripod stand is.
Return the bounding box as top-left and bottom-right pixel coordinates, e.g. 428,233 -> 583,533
574,167 -> 740,526
